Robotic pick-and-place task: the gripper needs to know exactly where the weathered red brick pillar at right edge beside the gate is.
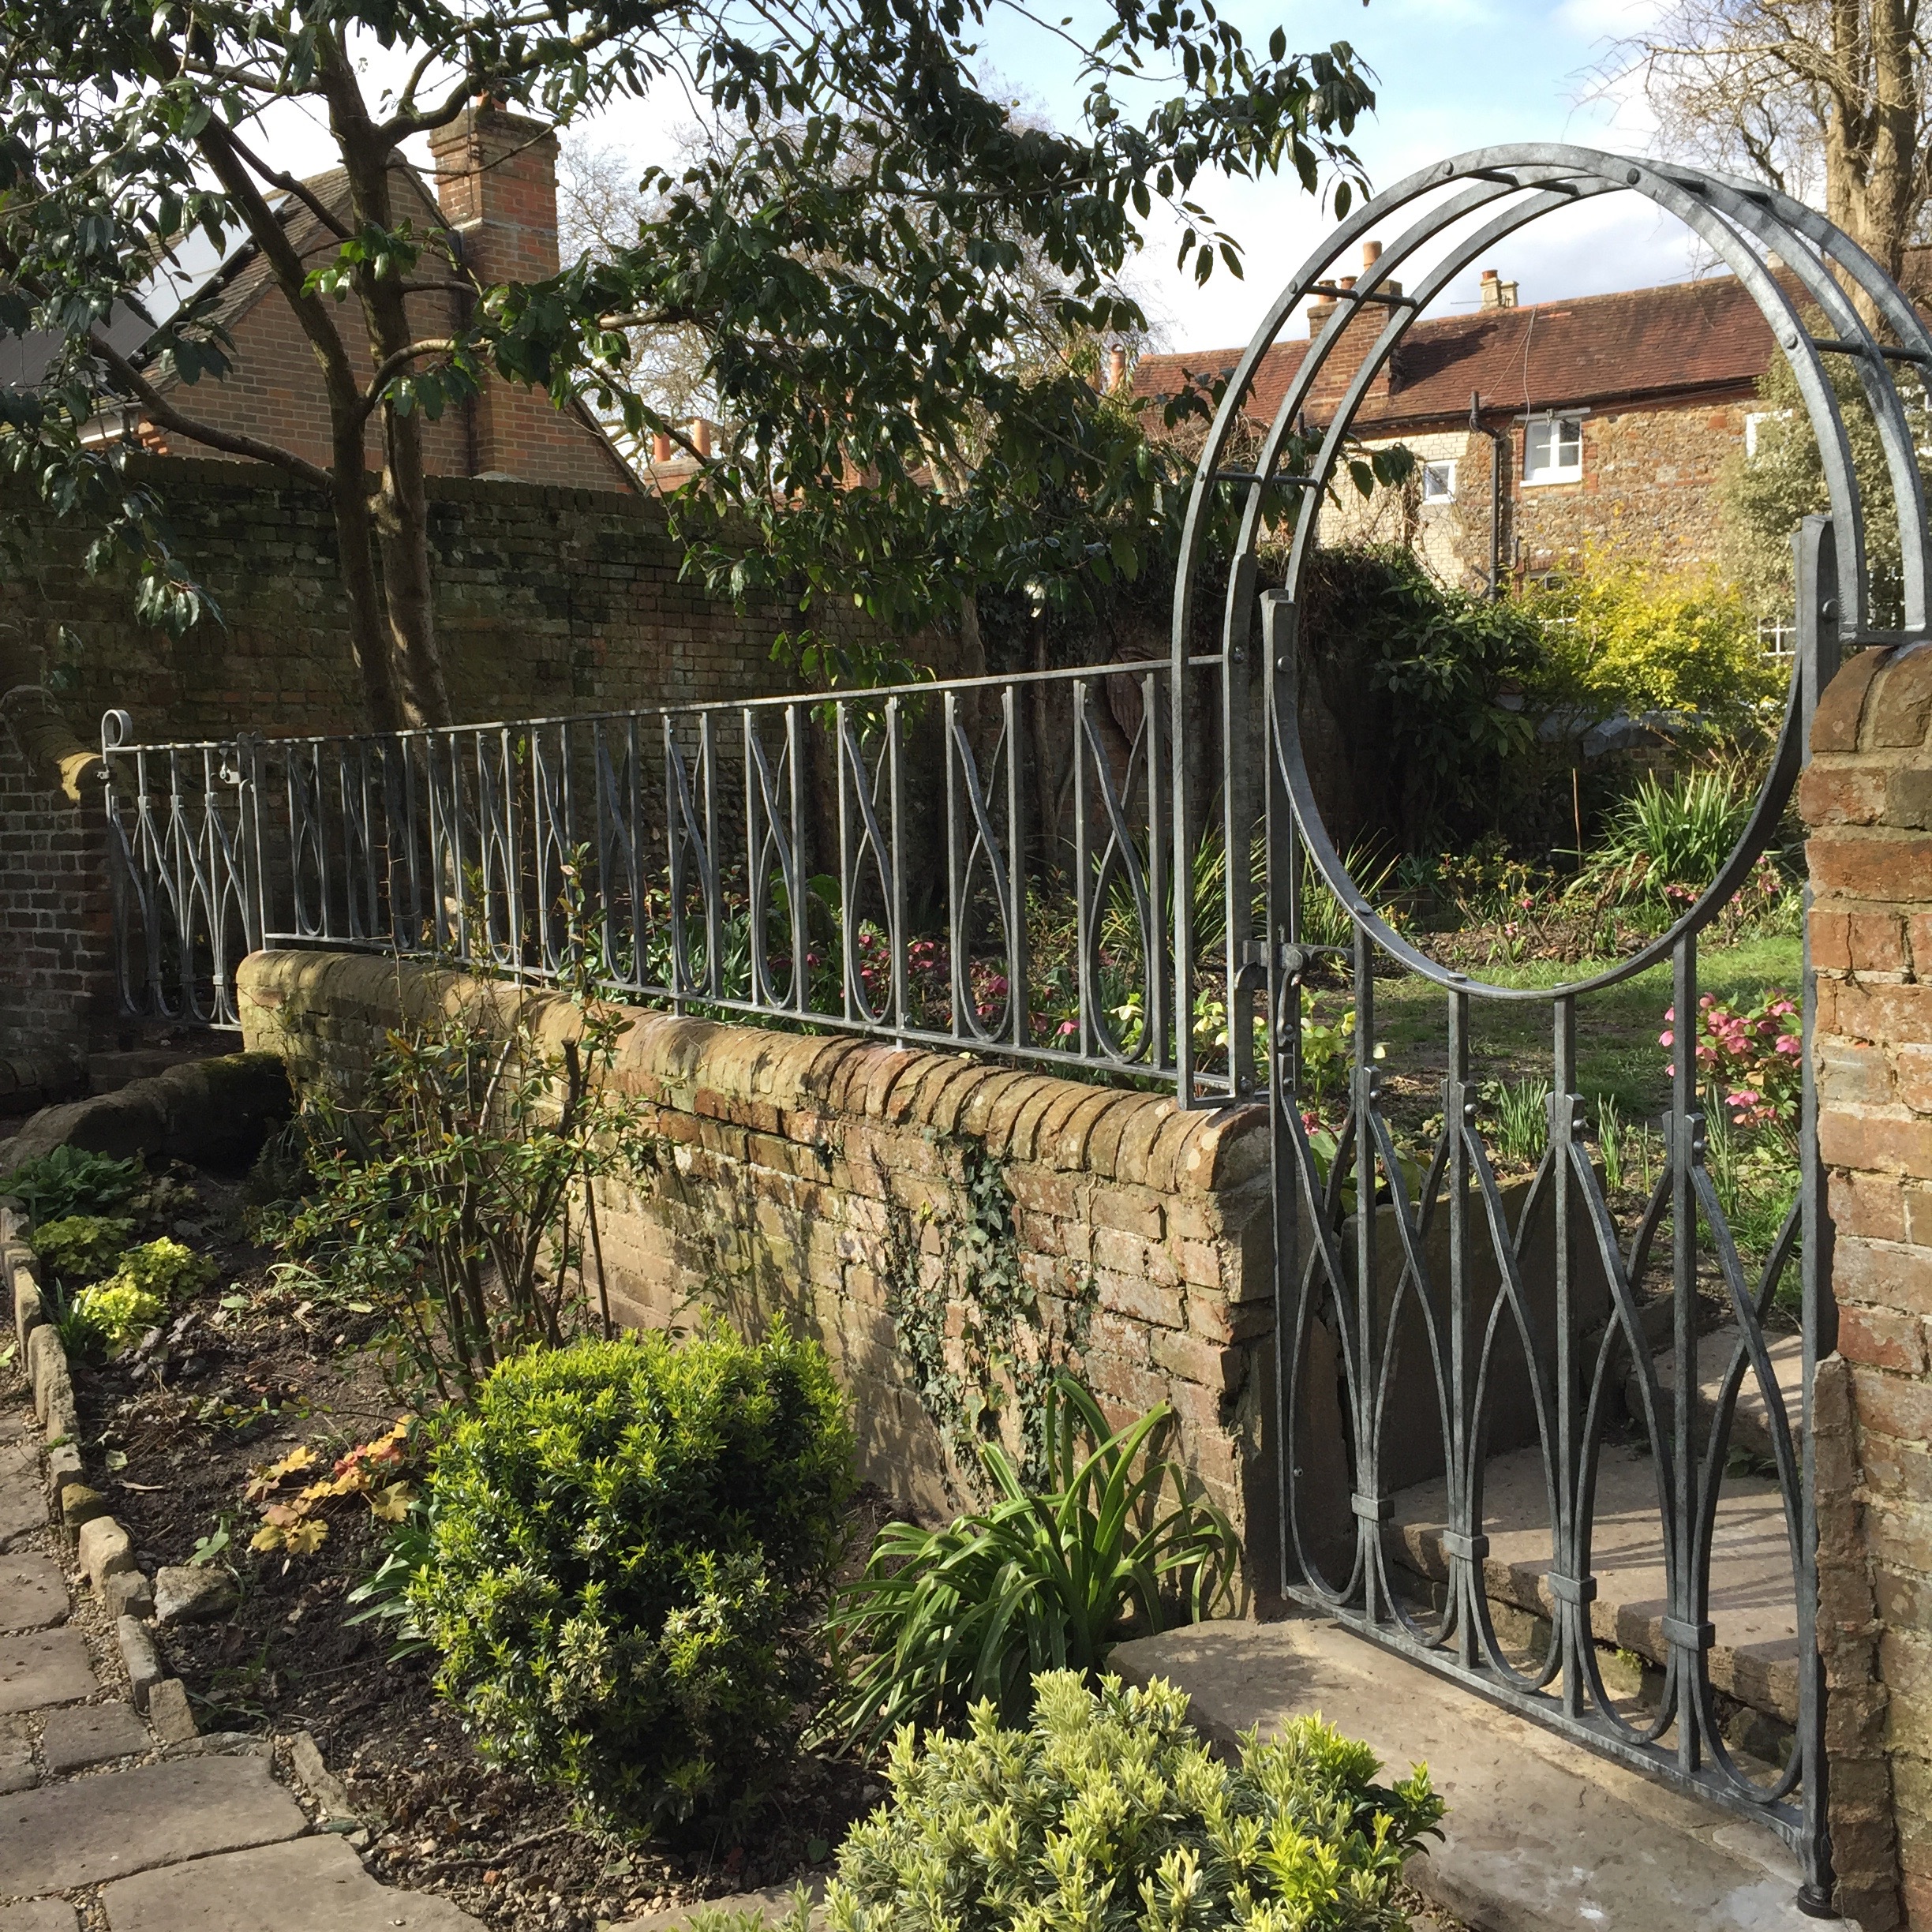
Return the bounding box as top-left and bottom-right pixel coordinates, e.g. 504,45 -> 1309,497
1799,643 -> 1932,1932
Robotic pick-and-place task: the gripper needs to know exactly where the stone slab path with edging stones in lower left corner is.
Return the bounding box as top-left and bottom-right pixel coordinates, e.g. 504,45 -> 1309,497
0,1410 -> 477,1932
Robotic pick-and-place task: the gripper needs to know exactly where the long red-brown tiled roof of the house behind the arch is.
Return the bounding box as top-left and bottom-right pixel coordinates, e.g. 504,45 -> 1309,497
1134,275 -> 1772,427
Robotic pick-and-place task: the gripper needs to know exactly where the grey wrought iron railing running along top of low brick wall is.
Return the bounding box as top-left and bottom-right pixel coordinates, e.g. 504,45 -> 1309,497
103,657 -> 1254,1099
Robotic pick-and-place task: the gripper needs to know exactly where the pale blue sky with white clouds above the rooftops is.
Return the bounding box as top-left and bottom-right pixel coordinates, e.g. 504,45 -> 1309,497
253,0 -> 1709,350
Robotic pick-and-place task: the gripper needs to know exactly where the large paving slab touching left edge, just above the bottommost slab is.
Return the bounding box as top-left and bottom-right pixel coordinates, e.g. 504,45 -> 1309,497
0,1758 -> 307,1897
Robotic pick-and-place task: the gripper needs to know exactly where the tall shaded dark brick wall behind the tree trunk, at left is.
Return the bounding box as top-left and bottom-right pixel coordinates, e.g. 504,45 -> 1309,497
0,456 -> 950,1057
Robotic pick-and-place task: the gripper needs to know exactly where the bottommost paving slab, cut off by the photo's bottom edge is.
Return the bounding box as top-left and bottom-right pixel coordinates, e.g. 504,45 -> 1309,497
100,1833 -> 481,1932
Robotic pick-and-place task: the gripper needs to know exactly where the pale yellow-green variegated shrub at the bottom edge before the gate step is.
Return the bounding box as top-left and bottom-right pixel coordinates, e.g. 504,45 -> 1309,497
811,1672 -> 1443,1932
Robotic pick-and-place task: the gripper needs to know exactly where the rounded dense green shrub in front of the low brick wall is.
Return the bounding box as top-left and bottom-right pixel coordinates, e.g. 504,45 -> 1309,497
410,1327 -> 854,1829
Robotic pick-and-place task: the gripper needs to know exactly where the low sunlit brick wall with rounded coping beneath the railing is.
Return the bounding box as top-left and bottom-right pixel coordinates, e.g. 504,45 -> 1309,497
242,953 -> 1275,1578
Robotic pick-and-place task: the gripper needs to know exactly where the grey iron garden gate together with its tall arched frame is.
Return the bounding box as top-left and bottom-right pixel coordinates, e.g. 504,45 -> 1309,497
1173,147 -> 1932,1916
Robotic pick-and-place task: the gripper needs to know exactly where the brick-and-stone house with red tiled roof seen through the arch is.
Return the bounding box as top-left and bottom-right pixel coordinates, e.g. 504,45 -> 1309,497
1133,242 -> 1808,587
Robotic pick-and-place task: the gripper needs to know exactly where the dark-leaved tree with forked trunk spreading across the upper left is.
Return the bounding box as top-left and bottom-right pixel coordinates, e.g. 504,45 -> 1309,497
0,0 -> 1374,726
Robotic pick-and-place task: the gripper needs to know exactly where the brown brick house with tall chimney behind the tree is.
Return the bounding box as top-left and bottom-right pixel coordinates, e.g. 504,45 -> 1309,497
114,107 -> 638,491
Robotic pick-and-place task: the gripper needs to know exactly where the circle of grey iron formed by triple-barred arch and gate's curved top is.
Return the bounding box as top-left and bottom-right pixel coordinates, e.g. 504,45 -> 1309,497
1173,145 -> 1932,1001
